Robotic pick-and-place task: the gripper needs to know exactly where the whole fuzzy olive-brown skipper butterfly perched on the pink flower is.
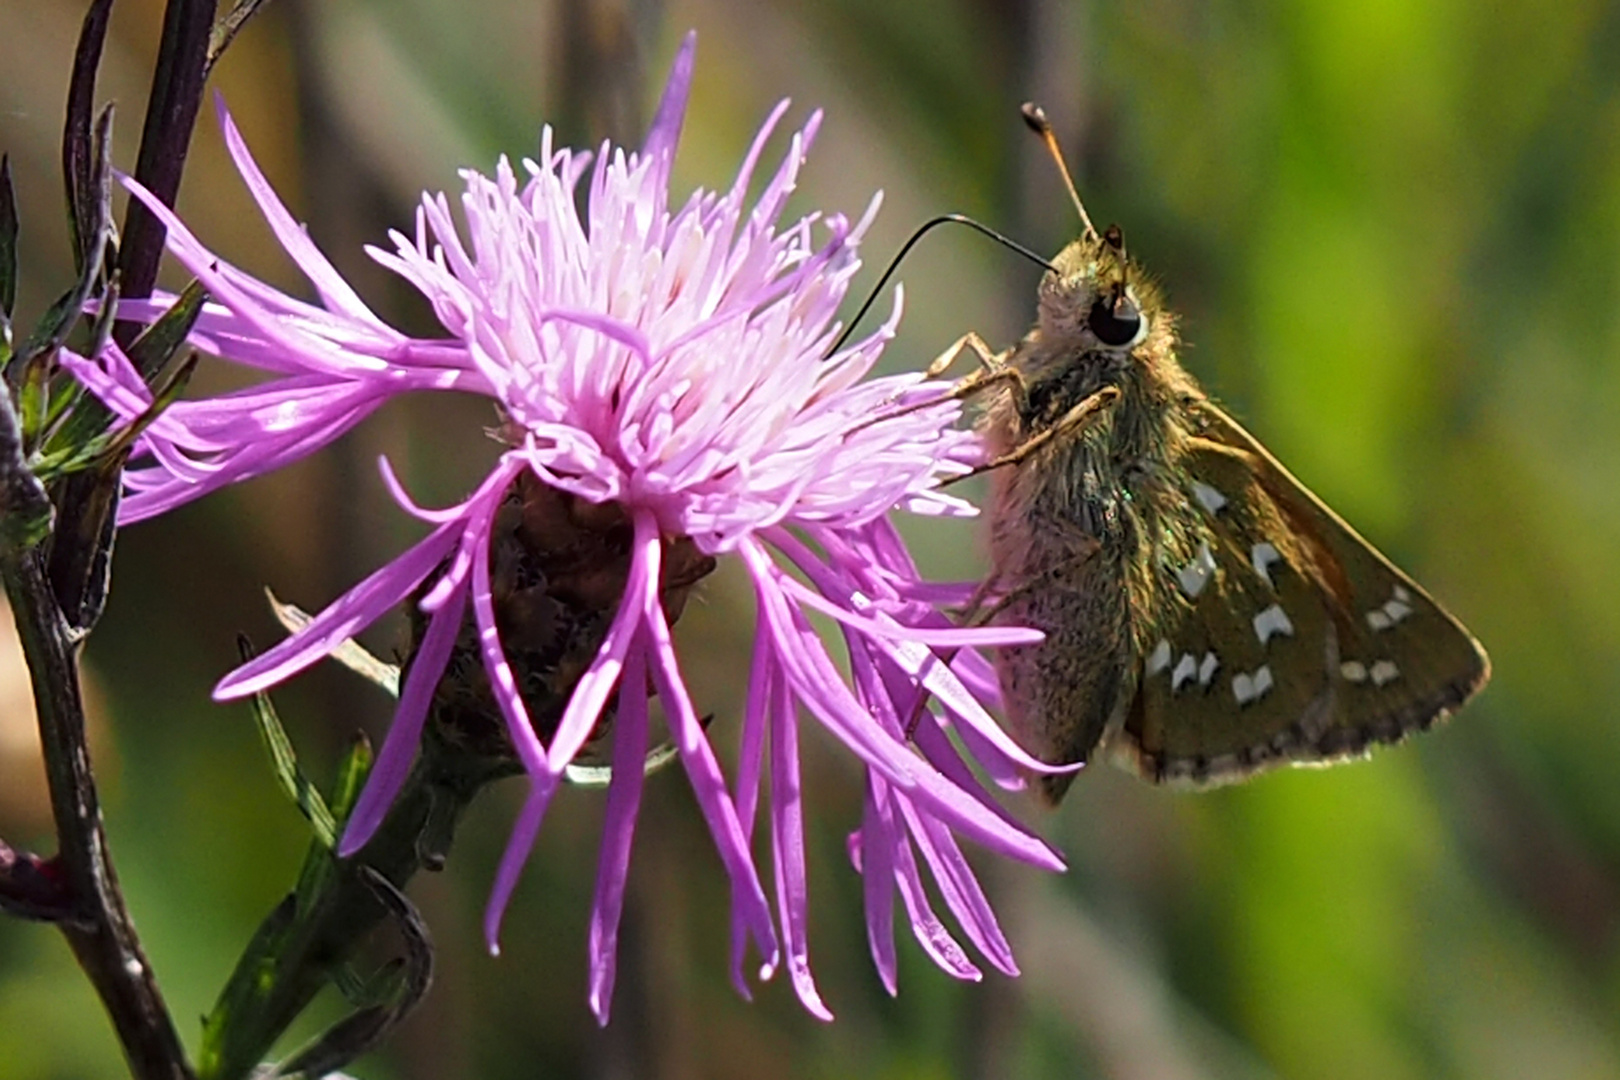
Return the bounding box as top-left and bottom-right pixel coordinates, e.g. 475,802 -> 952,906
953,107 -> 1490,801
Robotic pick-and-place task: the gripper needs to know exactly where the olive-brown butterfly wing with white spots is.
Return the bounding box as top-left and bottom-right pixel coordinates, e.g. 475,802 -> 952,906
1105,402 -> 1490,787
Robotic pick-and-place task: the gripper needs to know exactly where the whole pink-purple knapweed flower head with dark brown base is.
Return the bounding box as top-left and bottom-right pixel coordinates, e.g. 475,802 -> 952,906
71,37 -> 1061,1020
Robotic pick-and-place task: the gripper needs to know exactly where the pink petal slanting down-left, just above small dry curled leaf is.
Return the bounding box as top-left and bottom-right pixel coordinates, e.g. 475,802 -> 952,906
214,521 -> 465,701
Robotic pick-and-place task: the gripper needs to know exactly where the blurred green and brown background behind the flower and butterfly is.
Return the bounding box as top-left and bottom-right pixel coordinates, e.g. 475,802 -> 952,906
0,0 -> 1620,1080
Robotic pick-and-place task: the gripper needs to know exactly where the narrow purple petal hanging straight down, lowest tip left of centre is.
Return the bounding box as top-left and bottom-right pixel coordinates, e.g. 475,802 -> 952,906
588,644 -> 646,1027
